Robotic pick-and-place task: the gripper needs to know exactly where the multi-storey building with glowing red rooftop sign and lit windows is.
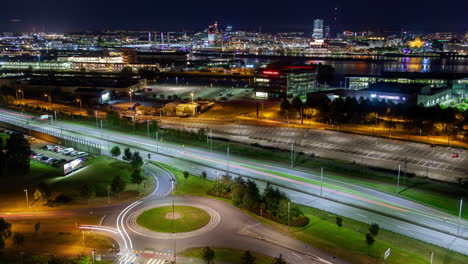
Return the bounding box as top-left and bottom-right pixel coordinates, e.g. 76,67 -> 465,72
254,66 -> 317,99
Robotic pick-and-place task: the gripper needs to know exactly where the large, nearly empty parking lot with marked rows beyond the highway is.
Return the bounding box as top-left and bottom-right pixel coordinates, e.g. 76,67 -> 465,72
160,119 -> 468,182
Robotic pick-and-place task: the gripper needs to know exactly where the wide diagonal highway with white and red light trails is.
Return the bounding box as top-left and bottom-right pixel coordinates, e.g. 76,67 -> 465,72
0,108 -> 468,254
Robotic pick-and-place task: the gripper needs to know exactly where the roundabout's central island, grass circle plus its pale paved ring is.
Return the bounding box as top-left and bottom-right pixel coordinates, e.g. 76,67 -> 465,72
127,202 -> 221,239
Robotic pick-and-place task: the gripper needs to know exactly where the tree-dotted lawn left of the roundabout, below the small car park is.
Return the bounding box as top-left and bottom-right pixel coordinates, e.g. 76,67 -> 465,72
0,156 -> 155,211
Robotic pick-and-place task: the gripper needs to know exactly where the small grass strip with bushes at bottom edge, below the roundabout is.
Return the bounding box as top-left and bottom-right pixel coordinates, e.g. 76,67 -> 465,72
179,248 -> 274,264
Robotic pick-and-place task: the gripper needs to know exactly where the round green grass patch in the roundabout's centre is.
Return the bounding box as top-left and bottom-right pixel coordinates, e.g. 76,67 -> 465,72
137,206 -> 210,233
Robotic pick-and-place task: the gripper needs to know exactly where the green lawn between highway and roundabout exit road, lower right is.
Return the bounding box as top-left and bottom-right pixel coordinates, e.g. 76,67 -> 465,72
252,206 -> 468,264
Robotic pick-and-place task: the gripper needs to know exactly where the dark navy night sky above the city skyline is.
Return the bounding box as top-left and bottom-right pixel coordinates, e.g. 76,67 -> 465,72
0,0 -> 468,32
